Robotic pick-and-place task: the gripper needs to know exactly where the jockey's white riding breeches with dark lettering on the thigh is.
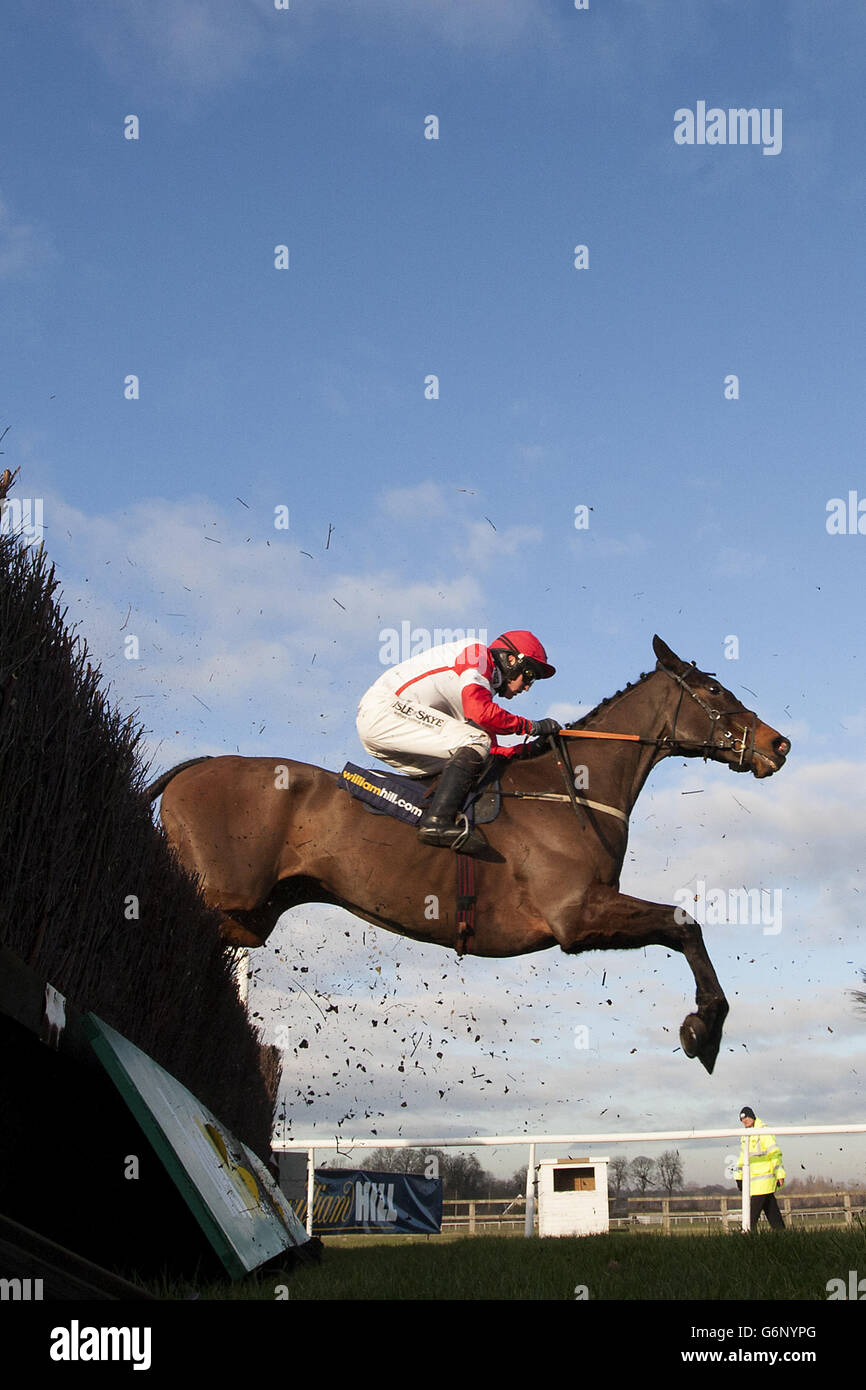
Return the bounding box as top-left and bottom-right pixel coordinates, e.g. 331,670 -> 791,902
356,695 -> 491,777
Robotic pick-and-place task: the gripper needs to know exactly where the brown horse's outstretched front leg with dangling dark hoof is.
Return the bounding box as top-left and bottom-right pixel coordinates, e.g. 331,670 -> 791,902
550,884 -> 728,1072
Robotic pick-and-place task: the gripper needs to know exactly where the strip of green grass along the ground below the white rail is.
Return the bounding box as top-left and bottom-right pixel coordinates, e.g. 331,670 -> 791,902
160,1229 -> 866,1302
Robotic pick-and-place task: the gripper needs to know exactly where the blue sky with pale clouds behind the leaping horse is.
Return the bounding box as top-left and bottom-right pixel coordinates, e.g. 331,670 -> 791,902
0,0 -> 866,1182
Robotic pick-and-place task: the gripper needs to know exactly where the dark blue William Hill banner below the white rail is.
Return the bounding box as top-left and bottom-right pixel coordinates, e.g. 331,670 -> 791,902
292,1168 -> 442,1236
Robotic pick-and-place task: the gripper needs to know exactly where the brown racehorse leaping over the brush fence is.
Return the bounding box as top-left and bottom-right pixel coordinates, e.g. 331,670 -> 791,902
143,637 -> 791,1073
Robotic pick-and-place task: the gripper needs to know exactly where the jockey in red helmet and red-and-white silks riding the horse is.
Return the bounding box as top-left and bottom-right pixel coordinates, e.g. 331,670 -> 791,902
357,631 -> 560,855
